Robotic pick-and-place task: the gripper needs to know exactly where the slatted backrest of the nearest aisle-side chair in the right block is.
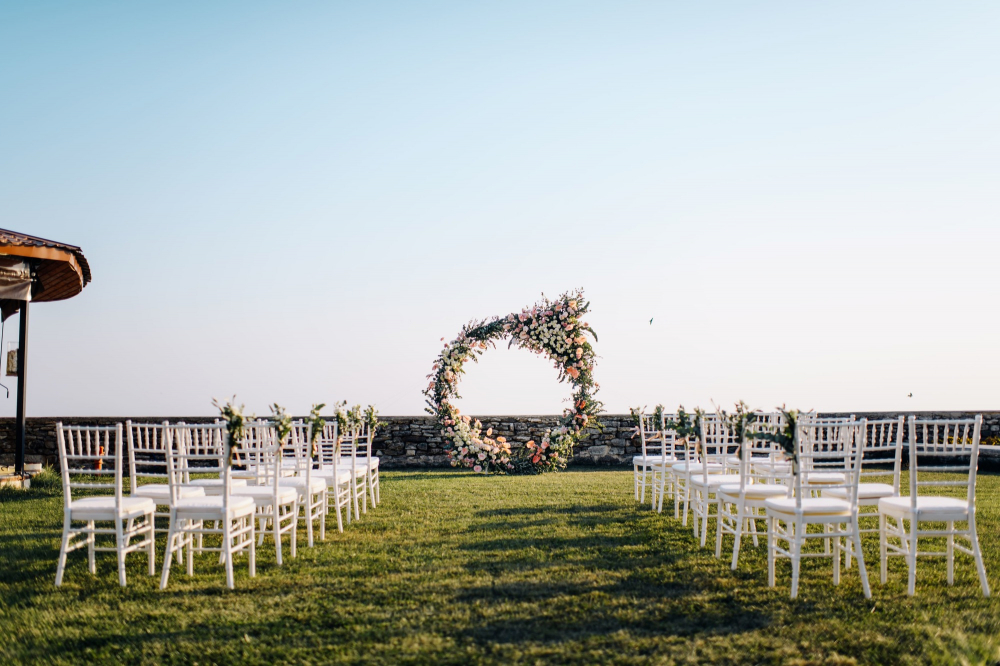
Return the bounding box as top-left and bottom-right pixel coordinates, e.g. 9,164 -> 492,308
791,419 -> 865,509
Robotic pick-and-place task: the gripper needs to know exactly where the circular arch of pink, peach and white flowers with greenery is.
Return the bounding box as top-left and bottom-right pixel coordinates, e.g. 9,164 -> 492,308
424,290 -> 601,474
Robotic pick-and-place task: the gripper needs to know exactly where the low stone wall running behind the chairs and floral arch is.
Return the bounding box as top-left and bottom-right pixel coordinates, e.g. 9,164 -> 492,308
0,412 -> 1000,467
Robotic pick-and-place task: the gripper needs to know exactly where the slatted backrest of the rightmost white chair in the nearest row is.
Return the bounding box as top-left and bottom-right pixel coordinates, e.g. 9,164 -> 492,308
908,414 -> 983,512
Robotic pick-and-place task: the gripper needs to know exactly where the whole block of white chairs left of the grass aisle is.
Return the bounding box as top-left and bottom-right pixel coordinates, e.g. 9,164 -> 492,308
56,421 -> 381,589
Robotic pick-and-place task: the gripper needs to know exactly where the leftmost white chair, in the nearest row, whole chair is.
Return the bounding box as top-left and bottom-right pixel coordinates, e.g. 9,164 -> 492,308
56,422 -> 156,587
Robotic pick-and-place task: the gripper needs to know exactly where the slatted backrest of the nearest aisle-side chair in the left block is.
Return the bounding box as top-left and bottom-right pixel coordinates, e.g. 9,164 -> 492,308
164,423 -> 233,506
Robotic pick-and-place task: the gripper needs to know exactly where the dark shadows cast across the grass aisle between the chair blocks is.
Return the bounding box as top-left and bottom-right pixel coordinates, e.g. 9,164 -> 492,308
456,504 -> 773,645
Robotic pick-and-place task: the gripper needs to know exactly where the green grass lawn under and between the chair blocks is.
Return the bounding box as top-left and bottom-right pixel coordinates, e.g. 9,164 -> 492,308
0,470 -> 1000,664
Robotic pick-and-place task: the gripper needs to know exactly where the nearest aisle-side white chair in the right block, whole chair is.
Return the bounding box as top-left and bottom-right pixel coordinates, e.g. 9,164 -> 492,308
764,418 -> 871,599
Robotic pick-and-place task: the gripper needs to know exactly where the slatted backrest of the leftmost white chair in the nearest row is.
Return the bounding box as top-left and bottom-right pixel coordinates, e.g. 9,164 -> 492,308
56,422 -> 122,512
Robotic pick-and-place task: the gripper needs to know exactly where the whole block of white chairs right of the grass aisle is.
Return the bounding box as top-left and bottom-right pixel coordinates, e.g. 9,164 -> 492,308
633,413 -> 990,598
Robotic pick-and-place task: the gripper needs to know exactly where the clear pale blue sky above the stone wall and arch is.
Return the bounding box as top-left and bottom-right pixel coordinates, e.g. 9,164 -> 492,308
0,2 -> 1000,416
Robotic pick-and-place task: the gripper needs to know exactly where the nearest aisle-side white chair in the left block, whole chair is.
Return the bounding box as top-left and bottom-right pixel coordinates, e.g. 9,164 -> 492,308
160,424 -> 257,589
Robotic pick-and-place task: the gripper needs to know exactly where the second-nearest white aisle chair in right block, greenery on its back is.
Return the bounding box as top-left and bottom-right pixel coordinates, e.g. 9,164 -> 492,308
715,414 -> 791,571
